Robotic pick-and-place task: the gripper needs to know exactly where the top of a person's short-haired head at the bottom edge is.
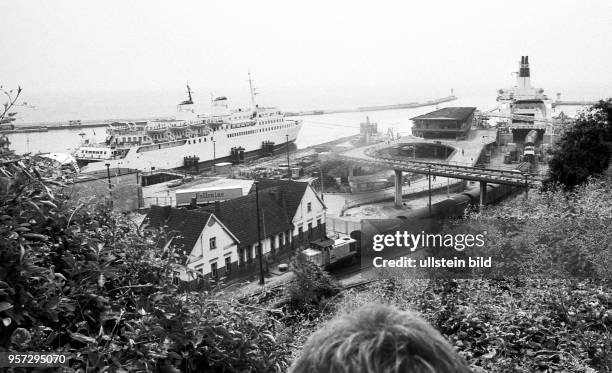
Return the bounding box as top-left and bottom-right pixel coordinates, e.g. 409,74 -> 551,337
290,304 -> 471,373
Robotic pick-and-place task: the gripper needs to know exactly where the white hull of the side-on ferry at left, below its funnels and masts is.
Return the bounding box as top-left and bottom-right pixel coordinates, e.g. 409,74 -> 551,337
79,120 -> 302,172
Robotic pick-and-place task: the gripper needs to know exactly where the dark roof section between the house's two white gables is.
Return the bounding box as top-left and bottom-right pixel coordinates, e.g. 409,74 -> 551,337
198,191 -> 291,246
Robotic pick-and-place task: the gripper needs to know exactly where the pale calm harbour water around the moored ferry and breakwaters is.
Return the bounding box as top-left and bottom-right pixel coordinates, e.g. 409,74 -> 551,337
7,90 -> 596,154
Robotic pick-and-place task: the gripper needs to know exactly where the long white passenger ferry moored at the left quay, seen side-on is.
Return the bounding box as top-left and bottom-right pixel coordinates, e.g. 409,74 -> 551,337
73,74 -> 302,172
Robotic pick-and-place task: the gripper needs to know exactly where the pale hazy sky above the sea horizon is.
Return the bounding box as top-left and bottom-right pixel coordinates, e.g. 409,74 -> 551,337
0,0 -> 612,96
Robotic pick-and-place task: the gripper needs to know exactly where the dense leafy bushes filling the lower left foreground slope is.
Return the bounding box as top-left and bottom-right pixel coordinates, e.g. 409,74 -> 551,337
0,158 -> 288,372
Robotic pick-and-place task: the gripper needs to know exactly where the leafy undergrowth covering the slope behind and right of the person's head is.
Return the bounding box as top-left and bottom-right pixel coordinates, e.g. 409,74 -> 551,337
295,178 -> 612,373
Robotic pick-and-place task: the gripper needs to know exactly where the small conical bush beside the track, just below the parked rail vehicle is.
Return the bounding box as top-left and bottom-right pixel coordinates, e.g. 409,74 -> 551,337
285,251 -> 340,310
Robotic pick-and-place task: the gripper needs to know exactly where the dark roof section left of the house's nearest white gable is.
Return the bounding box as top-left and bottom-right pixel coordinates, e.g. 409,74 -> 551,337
143,206 -> 211,250
